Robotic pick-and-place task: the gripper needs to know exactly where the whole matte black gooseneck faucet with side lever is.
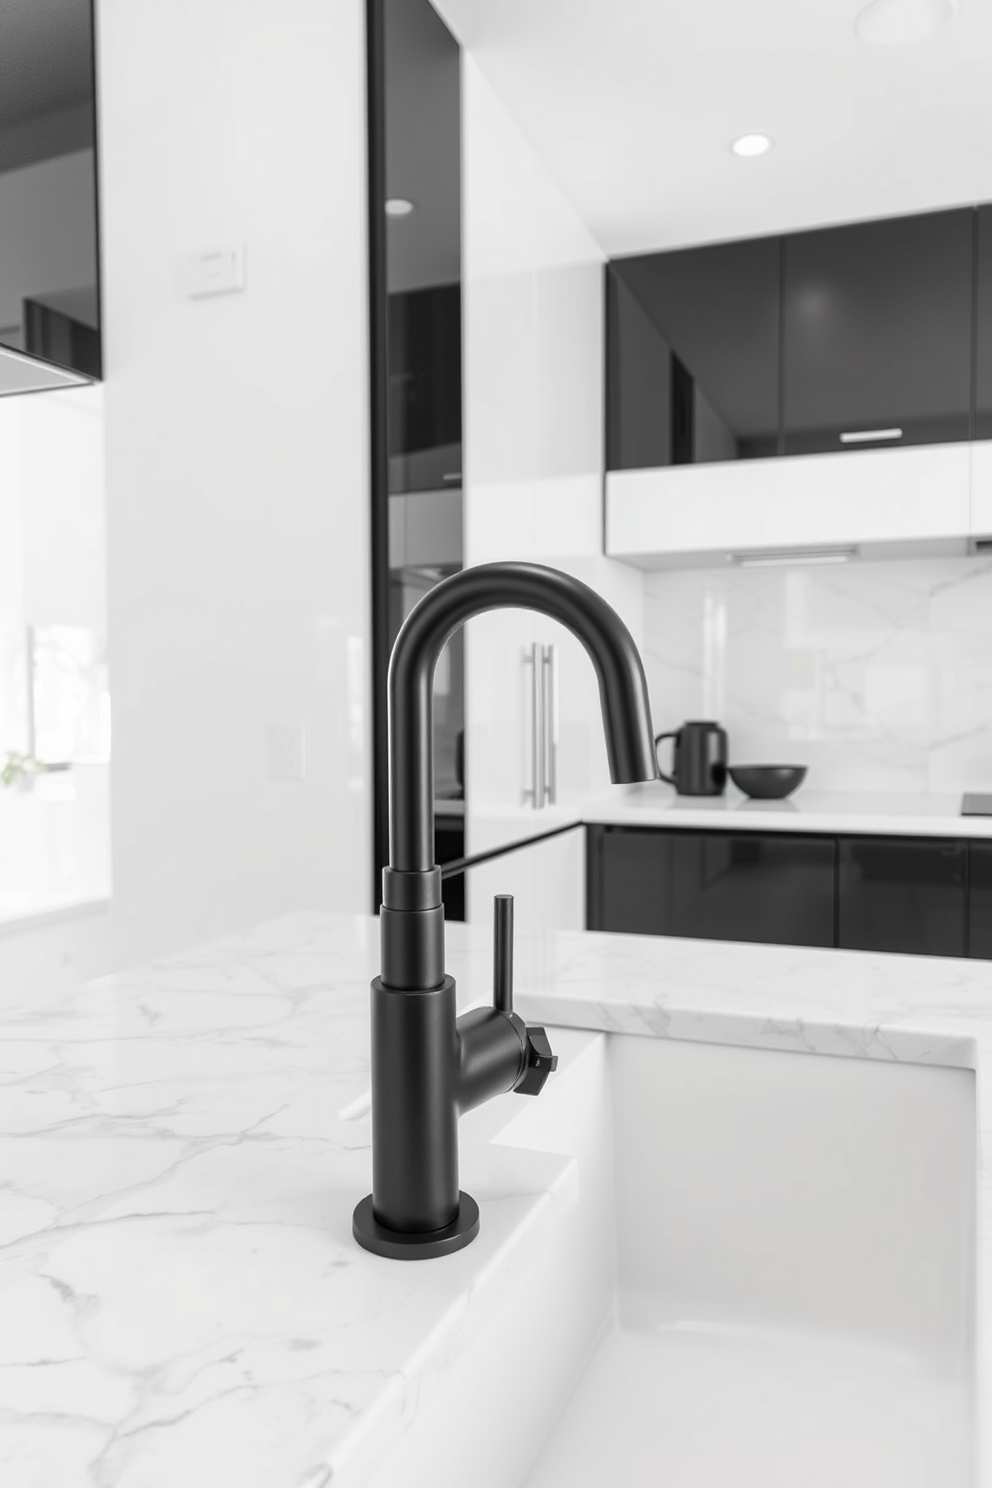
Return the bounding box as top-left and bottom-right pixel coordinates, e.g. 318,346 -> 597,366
352,562 -> 657,1260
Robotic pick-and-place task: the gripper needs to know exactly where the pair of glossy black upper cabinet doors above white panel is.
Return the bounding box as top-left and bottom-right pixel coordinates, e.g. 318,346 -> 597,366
607,207 -> 992,470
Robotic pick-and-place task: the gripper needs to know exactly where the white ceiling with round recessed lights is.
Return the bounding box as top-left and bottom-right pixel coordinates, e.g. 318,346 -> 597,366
433,0 -> 992,254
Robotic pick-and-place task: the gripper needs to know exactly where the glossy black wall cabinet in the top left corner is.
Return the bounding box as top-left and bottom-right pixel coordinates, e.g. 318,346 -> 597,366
0,0 -> 101,393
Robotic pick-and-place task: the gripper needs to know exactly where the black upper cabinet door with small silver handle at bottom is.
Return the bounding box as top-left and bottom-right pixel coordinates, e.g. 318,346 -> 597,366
782,208 -> 974,454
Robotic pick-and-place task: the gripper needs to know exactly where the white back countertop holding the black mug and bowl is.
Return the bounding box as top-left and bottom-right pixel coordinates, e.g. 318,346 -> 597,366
582,781 -> 992,838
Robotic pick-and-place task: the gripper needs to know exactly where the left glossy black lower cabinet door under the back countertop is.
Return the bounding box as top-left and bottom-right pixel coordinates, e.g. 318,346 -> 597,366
587,827 -> 836,946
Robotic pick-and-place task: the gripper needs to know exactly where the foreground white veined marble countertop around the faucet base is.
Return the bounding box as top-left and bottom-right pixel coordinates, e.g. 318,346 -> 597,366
0,914 -> 992,1488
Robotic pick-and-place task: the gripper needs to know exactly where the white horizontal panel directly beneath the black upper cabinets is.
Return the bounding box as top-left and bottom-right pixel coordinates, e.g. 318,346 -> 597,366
607,445 -> 971,567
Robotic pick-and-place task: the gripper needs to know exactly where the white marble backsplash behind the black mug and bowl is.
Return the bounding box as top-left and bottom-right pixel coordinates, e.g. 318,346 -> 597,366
644,558 -> 992,792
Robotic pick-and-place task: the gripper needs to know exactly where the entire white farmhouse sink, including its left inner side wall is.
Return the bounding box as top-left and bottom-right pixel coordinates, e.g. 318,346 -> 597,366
361,1030 -> 976,1488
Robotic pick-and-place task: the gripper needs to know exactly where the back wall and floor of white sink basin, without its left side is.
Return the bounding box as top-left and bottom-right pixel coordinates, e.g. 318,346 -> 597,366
526,1037 -> 976,1488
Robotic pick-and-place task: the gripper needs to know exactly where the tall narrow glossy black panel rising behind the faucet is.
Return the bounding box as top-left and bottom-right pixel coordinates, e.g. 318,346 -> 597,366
374,0 -> 464,920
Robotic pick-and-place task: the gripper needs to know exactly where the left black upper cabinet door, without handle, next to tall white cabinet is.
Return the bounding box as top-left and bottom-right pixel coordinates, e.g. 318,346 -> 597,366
607,238 -> 781,470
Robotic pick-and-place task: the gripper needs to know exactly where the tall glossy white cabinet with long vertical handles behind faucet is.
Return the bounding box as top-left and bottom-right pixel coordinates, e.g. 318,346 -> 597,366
463,55 -> 642,904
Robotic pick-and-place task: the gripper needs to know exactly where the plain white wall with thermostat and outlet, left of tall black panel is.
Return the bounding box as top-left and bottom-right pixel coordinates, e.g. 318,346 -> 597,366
97,0 -> 370,963
